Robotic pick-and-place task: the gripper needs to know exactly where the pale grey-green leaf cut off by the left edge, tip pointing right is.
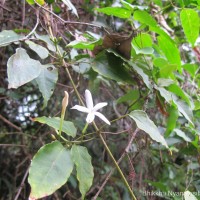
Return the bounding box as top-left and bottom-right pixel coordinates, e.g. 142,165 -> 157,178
0,30 -> 24,47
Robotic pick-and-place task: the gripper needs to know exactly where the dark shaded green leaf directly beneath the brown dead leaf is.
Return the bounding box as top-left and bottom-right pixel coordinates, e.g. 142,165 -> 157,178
92,51 -> 134,83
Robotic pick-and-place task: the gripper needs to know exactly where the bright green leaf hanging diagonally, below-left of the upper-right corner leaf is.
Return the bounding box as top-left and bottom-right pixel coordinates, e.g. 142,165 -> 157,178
157,36 -> 181,67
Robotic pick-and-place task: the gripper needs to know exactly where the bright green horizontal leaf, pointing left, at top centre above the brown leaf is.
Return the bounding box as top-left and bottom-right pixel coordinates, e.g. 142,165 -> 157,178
96,7 -> 131,19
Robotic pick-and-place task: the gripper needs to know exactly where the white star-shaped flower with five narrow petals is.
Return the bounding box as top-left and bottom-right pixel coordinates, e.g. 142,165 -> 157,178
71,90 -> 110,125
